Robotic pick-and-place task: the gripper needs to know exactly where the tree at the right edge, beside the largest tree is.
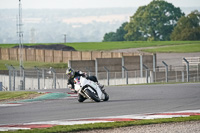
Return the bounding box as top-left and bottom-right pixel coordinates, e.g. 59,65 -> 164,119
171,10 -> 200,41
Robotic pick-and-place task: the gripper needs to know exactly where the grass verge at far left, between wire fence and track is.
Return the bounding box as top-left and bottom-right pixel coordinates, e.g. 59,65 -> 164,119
0,91 -> 39,102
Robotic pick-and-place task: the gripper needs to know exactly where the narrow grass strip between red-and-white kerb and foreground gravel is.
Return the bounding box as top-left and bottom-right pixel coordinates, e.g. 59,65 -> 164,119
2,116 -> 200,133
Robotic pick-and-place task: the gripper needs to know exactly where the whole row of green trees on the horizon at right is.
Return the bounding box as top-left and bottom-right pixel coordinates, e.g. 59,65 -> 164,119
103,0 -> 200,42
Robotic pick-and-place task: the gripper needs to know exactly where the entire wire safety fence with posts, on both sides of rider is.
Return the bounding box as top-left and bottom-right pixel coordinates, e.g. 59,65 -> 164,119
0,64 -> 200,91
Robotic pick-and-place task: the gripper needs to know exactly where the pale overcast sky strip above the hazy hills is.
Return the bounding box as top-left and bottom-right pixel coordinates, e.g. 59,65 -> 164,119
0,0 -> 200,9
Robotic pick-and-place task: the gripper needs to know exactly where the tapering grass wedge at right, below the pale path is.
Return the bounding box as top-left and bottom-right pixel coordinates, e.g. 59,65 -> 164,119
143,43 -> 200,53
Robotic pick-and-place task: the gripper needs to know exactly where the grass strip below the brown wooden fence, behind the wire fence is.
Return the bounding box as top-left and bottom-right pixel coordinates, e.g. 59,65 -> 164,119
0,60 -> 68,70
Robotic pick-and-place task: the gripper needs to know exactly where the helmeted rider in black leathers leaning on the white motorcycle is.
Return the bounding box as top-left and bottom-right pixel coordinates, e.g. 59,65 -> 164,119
66,67 -> 104,91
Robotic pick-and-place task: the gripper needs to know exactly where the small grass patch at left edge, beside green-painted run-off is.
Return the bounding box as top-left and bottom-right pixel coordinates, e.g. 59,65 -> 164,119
0,91 -> 37,101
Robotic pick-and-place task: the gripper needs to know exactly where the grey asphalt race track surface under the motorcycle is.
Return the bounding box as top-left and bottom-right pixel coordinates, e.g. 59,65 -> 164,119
0,83 -> 200,125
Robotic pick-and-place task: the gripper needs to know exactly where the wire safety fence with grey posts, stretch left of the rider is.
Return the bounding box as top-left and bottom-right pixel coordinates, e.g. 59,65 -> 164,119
0,67 -> 67,91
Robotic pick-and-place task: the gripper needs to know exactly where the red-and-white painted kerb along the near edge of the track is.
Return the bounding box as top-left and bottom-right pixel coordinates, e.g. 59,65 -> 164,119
0,110 -> 200,131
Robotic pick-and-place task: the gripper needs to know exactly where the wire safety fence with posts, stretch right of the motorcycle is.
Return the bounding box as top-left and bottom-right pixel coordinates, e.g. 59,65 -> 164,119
98,64 -> 200,85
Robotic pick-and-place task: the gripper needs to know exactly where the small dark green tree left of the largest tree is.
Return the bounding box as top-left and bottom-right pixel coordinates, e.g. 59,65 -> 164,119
103,22 -> 128,42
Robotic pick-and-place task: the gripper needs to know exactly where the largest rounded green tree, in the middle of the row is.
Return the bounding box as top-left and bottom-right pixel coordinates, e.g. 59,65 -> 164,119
125,0 -> 184,41
